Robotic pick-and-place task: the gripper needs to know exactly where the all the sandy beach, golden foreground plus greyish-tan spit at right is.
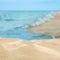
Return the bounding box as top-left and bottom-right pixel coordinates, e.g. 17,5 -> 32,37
0,12 -> 60,60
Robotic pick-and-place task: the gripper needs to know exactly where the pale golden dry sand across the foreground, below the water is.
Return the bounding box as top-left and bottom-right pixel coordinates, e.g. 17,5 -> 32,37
0,38 -> 60,60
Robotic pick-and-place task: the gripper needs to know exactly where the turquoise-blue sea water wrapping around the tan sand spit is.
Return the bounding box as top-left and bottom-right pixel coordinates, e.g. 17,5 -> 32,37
0,11 -> 54,40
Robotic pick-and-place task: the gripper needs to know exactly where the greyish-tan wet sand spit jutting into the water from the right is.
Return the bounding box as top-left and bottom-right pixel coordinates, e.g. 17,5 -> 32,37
28,12 -> 60,38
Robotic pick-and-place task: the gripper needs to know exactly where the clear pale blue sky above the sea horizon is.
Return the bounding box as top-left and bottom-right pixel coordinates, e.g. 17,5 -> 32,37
0,0 -> 60,10
